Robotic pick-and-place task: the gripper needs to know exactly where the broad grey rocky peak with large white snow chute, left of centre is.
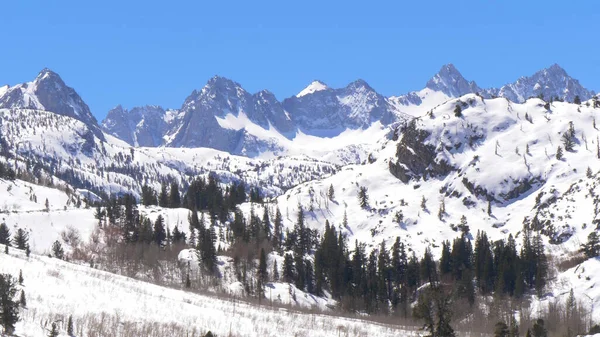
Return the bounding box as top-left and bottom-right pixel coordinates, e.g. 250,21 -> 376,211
167,76 -> 293,155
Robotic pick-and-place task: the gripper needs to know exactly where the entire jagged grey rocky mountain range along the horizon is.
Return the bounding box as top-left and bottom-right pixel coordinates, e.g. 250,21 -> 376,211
0,64 -> 594,157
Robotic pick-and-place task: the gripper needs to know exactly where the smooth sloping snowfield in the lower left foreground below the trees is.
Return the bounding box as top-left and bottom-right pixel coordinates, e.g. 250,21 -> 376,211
0,246 -> 418,337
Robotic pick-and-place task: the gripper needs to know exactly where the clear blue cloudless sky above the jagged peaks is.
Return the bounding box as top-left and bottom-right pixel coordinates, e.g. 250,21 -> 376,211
0,0 -> 600,119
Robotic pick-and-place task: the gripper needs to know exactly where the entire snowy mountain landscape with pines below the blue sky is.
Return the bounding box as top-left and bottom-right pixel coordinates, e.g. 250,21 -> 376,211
0,64 -> 600,336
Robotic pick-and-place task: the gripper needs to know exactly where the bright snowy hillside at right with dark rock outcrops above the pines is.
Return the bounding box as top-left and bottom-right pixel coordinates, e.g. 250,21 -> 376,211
268,94 -> 600,252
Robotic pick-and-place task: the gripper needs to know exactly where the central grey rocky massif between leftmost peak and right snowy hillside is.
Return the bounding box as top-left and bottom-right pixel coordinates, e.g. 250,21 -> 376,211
102,76 -> 408,157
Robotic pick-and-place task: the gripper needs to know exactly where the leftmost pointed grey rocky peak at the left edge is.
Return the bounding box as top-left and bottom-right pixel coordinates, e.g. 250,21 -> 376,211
0,68 -> 104,139
